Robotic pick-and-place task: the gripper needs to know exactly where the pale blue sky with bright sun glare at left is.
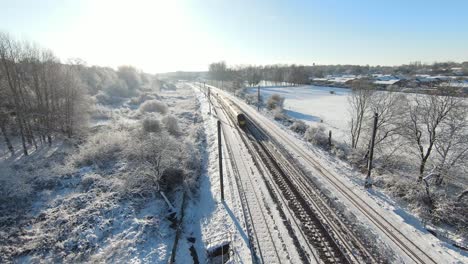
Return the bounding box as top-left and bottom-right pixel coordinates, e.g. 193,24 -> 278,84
0,0 -> 468,73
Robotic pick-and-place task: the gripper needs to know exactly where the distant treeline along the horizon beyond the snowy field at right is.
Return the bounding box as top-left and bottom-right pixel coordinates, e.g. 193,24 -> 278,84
208,61 -> 468,86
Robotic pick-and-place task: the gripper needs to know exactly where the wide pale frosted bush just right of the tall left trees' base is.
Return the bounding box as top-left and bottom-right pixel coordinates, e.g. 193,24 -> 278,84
70,130 -> 131,167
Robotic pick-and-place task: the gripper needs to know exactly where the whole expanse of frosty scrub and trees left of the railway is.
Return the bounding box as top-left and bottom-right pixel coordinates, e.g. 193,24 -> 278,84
0,35 -> 206,263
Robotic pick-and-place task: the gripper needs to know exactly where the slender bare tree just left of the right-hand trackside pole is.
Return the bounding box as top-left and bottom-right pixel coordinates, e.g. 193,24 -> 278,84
348,81 -> 374,149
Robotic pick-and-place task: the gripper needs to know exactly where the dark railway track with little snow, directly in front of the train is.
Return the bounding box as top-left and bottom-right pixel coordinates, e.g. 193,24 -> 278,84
243,123 -> 382,263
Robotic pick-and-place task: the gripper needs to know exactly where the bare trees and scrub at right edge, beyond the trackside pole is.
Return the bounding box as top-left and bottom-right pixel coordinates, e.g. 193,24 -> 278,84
348,82 -> 468,233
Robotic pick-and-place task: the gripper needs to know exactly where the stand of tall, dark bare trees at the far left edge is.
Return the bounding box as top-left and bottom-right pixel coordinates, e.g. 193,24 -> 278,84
0,33 -> 87,155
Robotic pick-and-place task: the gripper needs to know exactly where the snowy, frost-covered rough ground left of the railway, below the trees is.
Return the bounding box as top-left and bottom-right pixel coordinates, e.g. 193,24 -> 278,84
0,84 -> 204,263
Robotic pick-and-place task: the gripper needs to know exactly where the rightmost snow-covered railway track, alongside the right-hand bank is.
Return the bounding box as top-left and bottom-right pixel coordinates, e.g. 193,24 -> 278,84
218,89 -> 437,263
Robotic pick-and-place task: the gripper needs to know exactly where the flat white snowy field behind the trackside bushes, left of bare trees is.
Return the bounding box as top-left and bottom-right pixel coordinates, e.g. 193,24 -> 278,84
249,85 -> 351,141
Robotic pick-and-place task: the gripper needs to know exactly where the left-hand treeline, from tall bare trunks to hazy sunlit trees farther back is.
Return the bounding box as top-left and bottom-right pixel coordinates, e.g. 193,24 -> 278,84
0,32 -> 158,155
